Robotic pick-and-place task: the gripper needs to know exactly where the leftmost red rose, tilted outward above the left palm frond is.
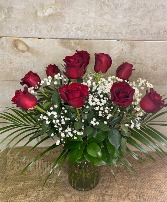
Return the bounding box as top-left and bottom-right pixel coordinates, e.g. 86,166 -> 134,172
11,87 -> 37,109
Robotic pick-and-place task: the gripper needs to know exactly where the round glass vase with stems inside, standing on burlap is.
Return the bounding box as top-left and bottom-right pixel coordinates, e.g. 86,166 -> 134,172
68,161 -> 100,191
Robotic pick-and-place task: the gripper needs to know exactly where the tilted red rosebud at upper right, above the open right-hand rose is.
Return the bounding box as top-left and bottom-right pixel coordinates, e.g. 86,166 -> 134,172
116,62 -> 133,80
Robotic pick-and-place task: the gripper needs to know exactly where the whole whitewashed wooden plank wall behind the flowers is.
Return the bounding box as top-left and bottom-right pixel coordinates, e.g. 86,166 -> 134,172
0,0 -> 167,148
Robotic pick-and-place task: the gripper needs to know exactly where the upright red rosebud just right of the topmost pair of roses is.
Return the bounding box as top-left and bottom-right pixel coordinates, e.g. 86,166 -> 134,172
94,53 -> 112,73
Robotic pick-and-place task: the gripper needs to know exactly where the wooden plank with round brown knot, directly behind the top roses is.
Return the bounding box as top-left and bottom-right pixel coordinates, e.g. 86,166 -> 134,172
0,37 -> 167,85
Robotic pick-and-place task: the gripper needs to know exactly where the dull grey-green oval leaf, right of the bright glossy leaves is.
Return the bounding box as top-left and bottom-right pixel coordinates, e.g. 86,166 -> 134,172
108,128 -> 121,149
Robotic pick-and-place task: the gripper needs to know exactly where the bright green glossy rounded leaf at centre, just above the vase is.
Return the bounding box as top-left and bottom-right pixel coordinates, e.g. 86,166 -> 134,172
86,142 -> 102,157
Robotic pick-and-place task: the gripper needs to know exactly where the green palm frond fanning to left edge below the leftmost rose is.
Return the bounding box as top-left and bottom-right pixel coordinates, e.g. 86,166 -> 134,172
0,108 -> 39,159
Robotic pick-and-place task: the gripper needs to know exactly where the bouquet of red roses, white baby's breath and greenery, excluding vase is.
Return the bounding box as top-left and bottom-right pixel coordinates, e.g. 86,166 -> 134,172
0,51 -> 167,183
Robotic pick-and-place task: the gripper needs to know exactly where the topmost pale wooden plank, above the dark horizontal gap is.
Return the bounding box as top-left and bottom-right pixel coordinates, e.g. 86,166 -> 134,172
0,0 -> 167,40
